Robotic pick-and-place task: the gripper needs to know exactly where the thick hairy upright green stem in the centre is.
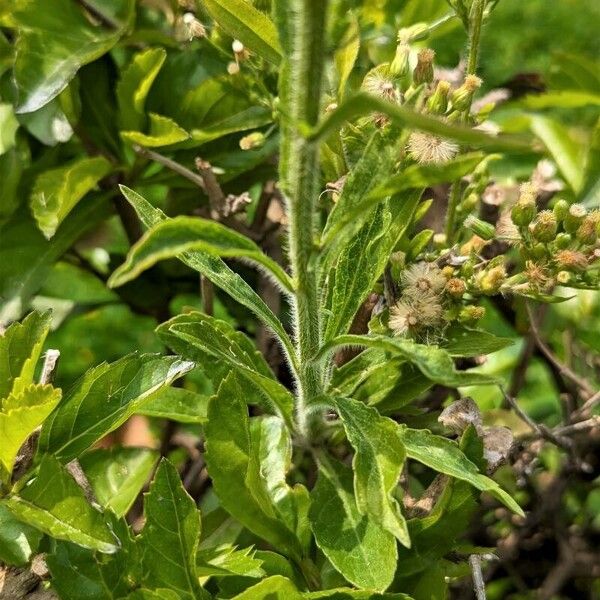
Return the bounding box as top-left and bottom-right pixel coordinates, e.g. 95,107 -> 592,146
280,0 -> 327,437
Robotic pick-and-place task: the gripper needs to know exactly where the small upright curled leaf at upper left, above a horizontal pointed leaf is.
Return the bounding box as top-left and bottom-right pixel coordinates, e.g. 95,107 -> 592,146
117,48 -> 167,131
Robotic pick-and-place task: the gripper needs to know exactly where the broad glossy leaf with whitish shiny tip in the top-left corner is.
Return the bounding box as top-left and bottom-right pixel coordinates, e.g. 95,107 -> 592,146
13,0 -> 133,113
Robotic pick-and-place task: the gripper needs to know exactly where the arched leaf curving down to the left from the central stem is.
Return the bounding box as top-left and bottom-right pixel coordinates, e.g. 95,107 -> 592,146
109,217 -> 293,292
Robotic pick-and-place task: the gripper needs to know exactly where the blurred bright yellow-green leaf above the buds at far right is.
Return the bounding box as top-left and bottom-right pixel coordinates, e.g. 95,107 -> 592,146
531,115 -> 583,194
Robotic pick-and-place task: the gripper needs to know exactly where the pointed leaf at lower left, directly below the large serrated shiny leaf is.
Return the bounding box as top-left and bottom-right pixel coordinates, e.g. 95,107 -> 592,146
5,456 -> 119,554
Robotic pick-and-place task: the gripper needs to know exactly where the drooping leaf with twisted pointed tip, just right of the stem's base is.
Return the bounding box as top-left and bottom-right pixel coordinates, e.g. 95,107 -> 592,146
335,398 -> 410,546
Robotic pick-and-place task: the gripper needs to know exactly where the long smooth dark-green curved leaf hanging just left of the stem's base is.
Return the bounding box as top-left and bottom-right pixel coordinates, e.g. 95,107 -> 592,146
204,373 -> 301,560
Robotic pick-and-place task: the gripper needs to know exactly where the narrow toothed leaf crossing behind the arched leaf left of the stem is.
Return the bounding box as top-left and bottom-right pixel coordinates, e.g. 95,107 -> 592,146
120,186 -> 296,369
